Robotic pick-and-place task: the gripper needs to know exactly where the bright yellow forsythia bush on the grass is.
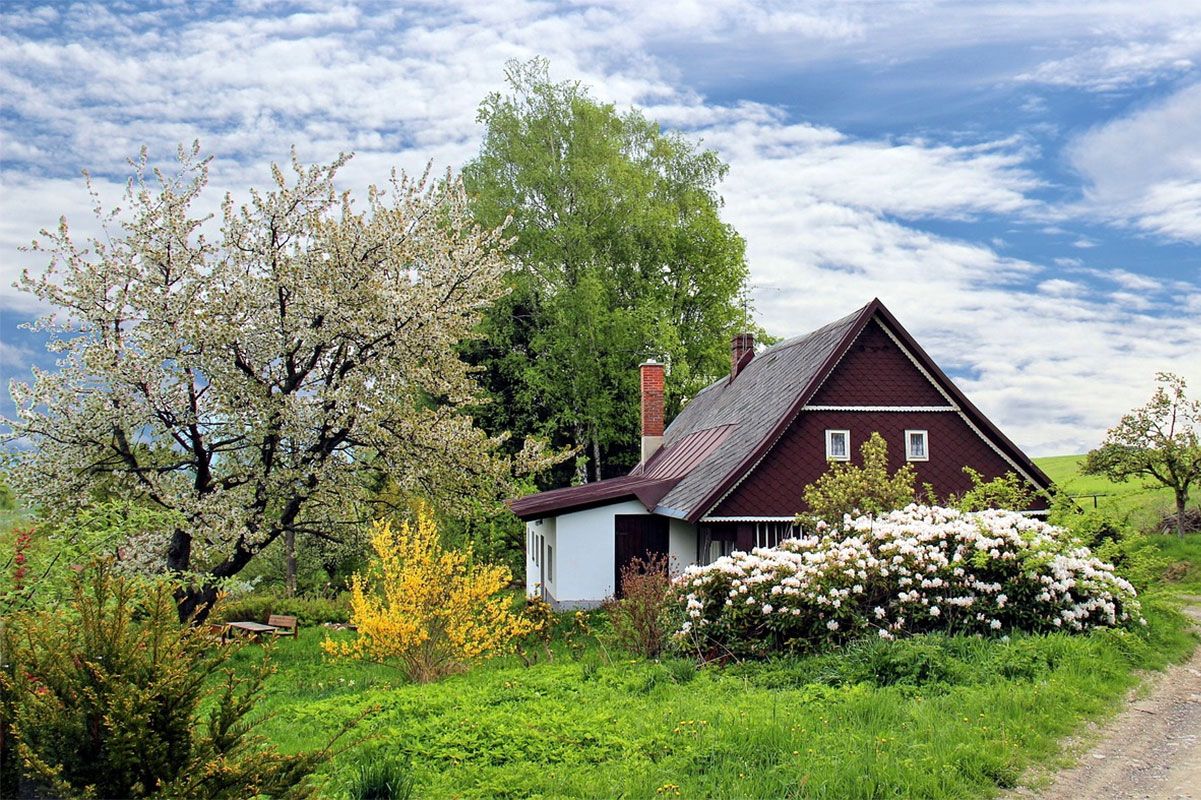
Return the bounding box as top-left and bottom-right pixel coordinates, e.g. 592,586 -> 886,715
322,509 -> 531,683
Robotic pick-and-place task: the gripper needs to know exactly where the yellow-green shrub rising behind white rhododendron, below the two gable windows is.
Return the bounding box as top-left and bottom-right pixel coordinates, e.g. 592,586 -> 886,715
797,432 -> 916,525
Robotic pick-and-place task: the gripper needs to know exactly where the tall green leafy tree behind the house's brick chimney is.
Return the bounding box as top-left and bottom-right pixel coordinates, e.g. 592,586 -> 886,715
464,59 -> 747,480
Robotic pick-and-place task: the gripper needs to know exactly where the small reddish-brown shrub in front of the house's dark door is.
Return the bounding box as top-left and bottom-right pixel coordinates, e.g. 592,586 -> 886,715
605,554 -> 671,658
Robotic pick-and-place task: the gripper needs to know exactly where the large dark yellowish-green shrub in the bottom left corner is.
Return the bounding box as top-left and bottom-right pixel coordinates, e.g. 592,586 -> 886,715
0,562 -> 343,798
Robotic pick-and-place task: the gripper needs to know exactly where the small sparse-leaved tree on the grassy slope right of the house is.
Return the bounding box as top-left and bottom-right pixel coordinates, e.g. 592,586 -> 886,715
1082,372 -> 1201,536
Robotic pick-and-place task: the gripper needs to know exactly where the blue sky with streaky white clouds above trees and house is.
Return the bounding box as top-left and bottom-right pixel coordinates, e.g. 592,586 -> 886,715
0,0 -> 1201,456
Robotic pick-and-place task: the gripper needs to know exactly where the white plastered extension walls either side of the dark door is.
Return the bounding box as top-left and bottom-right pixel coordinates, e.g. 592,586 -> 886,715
526,500 -> 697,608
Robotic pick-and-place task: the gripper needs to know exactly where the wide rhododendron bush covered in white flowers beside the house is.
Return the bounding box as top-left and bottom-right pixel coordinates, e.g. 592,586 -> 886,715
675,506 -> 1141,657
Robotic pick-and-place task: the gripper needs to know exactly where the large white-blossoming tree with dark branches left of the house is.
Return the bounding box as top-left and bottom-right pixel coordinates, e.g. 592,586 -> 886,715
8,145 -> 550,615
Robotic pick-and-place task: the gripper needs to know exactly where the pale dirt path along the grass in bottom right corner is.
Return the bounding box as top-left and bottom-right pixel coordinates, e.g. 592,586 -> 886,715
1006,598 -> 1201,800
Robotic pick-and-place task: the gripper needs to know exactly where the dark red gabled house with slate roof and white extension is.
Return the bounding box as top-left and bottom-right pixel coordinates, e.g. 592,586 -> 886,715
509,299 -> 1051,608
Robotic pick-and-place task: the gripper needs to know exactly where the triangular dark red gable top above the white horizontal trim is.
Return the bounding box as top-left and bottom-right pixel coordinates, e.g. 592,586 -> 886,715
809,320 -> 950,406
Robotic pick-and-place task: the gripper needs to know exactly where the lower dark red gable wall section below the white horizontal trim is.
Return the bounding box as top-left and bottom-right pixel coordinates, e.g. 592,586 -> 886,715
710,404 -> 1046,517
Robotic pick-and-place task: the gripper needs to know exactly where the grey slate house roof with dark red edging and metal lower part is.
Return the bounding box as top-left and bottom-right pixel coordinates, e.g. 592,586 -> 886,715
509,299 -> 1051,523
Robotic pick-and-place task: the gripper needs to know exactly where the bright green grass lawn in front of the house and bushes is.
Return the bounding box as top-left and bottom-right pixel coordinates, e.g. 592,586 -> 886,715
239,600 -> 1190,798
